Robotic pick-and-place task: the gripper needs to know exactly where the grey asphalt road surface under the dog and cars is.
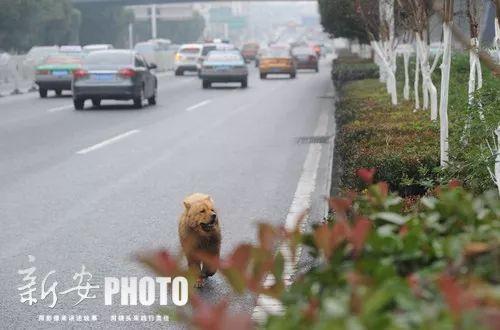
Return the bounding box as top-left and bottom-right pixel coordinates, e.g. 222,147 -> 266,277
0,60 -> 333,329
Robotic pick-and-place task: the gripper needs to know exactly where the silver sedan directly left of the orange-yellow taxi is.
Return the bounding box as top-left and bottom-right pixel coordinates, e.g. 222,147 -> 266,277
200,50 -> 248,88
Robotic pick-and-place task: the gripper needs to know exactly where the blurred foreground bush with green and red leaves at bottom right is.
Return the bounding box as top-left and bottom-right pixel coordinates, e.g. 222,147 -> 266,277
266,184 -> 500,330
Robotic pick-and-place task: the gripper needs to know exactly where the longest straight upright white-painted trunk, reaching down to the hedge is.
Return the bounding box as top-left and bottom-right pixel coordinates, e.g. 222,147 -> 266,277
439,22 -> 453,167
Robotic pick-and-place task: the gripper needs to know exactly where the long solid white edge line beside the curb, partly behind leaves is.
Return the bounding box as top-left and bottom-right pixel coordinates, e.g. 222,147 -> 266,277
252,112 -> 328,322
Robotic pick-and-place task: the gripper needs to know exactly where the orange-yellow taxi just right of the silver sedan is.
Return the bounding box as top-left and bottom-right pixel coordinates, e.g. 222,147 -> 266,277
259,47 -> 297,79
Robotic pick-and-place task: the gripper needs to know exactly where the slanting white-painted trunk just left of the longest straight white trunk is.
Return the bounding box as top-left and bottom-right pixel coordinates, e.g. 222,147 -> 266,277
416,33 -> 438,120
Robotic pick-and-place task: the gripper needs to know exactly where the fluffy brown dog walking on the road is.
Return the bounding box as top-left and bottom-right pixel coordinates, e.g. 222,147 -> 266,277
179,193 -> 221,287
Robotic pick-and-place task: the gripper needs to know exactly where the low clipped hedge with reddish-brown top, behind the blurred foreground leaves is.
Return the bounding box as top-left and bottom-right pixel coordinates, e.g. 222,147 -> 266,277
335,79 -> 439,196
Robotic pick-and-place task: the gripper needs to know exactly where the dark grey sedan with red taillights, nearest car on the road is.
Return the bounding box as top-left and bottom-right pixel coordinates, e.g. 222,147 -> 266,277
72,50 -> 158,110
